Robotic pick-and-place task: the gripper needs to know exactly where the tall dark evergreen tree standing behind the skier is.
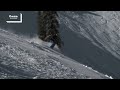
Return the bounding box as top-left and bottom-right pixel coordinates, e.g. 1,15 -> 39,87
38,11 -> 63,49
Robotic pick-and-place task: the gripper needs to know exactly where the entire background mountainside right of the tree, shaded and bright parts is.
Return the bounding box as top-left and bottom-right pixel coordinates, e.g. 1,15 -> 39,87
59,11 -> 120,78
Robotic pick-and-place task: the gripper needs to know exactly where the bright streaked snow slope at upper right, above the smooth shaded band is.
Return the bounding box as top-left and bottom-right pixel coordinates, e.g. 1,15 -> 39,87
59,11 -> 120,58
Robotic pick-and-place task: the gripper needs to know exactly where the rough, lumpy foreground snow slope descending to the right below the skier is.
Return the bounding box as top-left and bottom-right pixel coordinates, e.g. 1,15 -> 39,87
0,29 -> 108,79
